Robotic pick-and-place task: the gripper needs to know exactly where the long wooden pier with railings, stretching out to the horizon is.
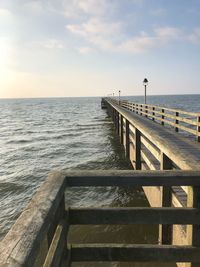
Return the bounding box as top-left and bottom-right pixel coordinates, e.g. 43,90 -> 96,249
0,98 -> 200,267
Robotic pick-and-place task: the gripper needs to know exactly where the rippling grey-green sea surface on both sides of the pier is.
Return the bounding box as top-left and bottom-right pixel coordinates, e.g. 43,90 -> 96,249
0,95 -> 200,267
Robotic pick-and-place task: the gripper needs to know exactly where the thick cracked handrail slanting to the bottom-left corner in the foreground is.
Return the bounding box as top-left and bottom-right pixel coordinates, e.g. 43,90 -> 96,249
0,173 -> 66,267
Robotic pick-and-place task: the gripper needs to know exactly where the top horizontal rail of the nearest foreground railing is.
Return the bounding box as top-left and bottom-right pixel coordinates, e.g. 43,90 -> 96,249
65,170 -> 200,187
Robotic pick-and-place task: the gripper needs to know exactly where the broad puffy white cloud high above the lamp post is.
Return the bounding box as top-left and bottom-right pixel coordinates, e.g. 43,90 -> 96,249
66,18 -> 187,54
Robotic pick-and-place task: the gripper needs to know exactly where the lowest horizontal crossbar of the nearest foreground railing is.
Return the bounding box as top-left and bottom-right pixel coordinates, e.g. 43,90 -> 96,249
71,244 -> 200,263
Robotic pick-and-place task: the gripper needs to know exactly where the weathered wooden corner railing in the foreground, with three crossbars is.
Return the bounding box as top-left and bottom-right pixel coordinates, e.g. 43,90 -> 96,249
0,171 -> 200,267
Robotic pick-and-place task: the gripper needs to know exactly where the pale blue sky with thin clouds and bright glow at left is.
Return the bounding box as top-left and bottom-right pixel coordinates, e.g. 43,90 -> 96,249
0,0 -> 200,98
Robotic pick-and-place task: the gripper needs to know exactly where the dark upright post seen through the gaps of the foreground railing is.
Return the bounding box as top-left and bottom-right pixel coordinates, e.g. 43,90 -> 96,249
159,152 -> 173,244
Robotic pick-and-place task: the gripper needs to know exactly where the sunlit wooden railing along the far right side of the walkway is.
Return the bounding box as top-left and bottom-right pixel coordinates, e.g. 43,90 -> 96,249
111,99 -> 200,142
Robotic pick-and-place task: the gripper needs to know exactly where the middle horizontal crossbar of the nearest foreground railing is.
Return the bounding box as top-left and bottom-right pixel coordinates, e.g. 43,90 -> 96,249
69,207 -> 200,225
